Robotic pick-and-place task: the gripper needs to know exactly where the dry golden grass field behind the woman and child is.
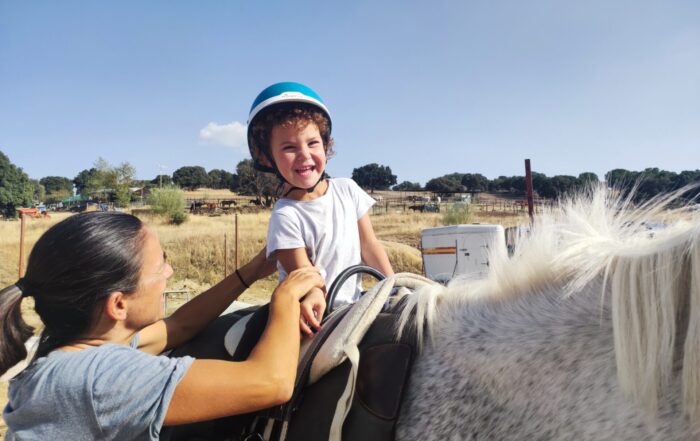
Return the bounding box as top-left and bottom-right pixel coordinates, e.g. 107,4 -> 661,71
0,201 -> 525,439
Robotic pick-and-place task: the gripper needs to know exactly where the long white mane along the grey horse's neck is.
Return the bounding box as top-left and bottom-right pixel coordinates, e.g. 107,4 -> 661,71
400,185 -> 700,419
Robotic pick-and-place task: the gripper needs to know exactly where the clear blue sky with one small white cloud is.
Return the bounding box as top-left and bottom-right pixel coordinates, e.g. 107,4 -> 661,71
0,0 -> 700,184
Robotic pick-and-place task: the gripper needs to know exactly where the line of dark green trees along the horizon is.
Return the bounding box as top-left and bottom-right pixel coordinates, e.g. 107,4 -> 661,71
0,152 -> 700,215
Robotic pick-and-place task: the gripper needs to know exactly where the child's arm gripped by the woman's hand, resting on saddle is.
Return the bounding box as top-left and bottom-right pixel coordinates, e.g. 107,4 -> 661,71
275,248 -> 326,335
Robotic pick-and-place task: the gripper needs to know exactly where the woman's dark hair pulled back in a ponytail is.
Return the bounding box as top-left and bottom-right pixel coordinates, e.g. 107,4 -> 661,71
0,213 -> 143,374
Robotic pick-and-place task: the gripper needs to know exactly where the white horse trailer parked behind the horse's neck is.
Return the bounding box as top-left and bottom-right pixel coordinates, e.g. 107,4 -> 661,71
421,224 -> 507,283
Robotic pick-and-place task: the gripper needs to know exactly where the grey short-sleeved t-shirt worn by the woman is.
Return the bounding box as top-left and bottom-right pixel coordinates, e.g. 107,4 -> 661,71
3,342 -> 194,441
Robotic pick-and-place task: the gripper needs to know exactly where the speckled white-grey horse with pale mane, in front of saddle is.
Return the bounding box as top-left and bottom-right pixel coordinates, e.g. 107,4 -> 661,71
397,189 -> 700,441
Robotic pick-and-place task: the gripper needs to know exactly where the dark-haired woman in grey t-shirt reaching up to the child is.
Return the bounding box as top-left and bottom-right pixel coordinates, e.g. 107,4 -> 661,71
0,213 -> 323,440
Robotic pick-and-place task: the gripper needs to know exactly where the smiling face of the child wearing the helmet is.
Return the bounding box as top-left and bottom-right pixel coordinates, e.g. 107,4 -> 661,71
270,122 -> 326,196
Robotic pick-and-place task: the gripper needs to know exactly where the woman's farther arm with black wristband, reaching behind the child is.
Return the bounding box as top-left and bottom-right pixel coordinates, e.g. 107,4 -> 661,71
139,248 -> 275,354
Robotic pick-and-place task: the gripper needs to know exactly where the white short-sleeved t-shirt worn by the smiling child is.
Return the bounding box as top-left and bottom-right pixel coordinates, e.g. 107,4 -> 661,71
267,178 -> 375,306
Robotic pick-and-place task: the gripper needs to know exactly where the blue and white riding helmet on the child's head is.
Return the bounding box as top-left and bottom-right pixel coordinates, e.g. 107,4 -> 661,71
248,82 -> 331,173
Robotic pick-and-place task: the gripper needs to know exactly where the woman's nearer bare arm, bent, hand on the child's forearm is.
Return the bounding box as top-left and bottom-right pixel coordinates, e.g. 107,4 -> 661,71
164,267 -> 324,425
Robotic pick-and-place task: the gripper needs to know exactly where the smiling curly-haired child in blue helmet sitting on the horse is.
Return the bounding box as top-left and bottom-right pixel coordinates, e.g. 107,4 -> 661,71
248,83 -> 393,335
